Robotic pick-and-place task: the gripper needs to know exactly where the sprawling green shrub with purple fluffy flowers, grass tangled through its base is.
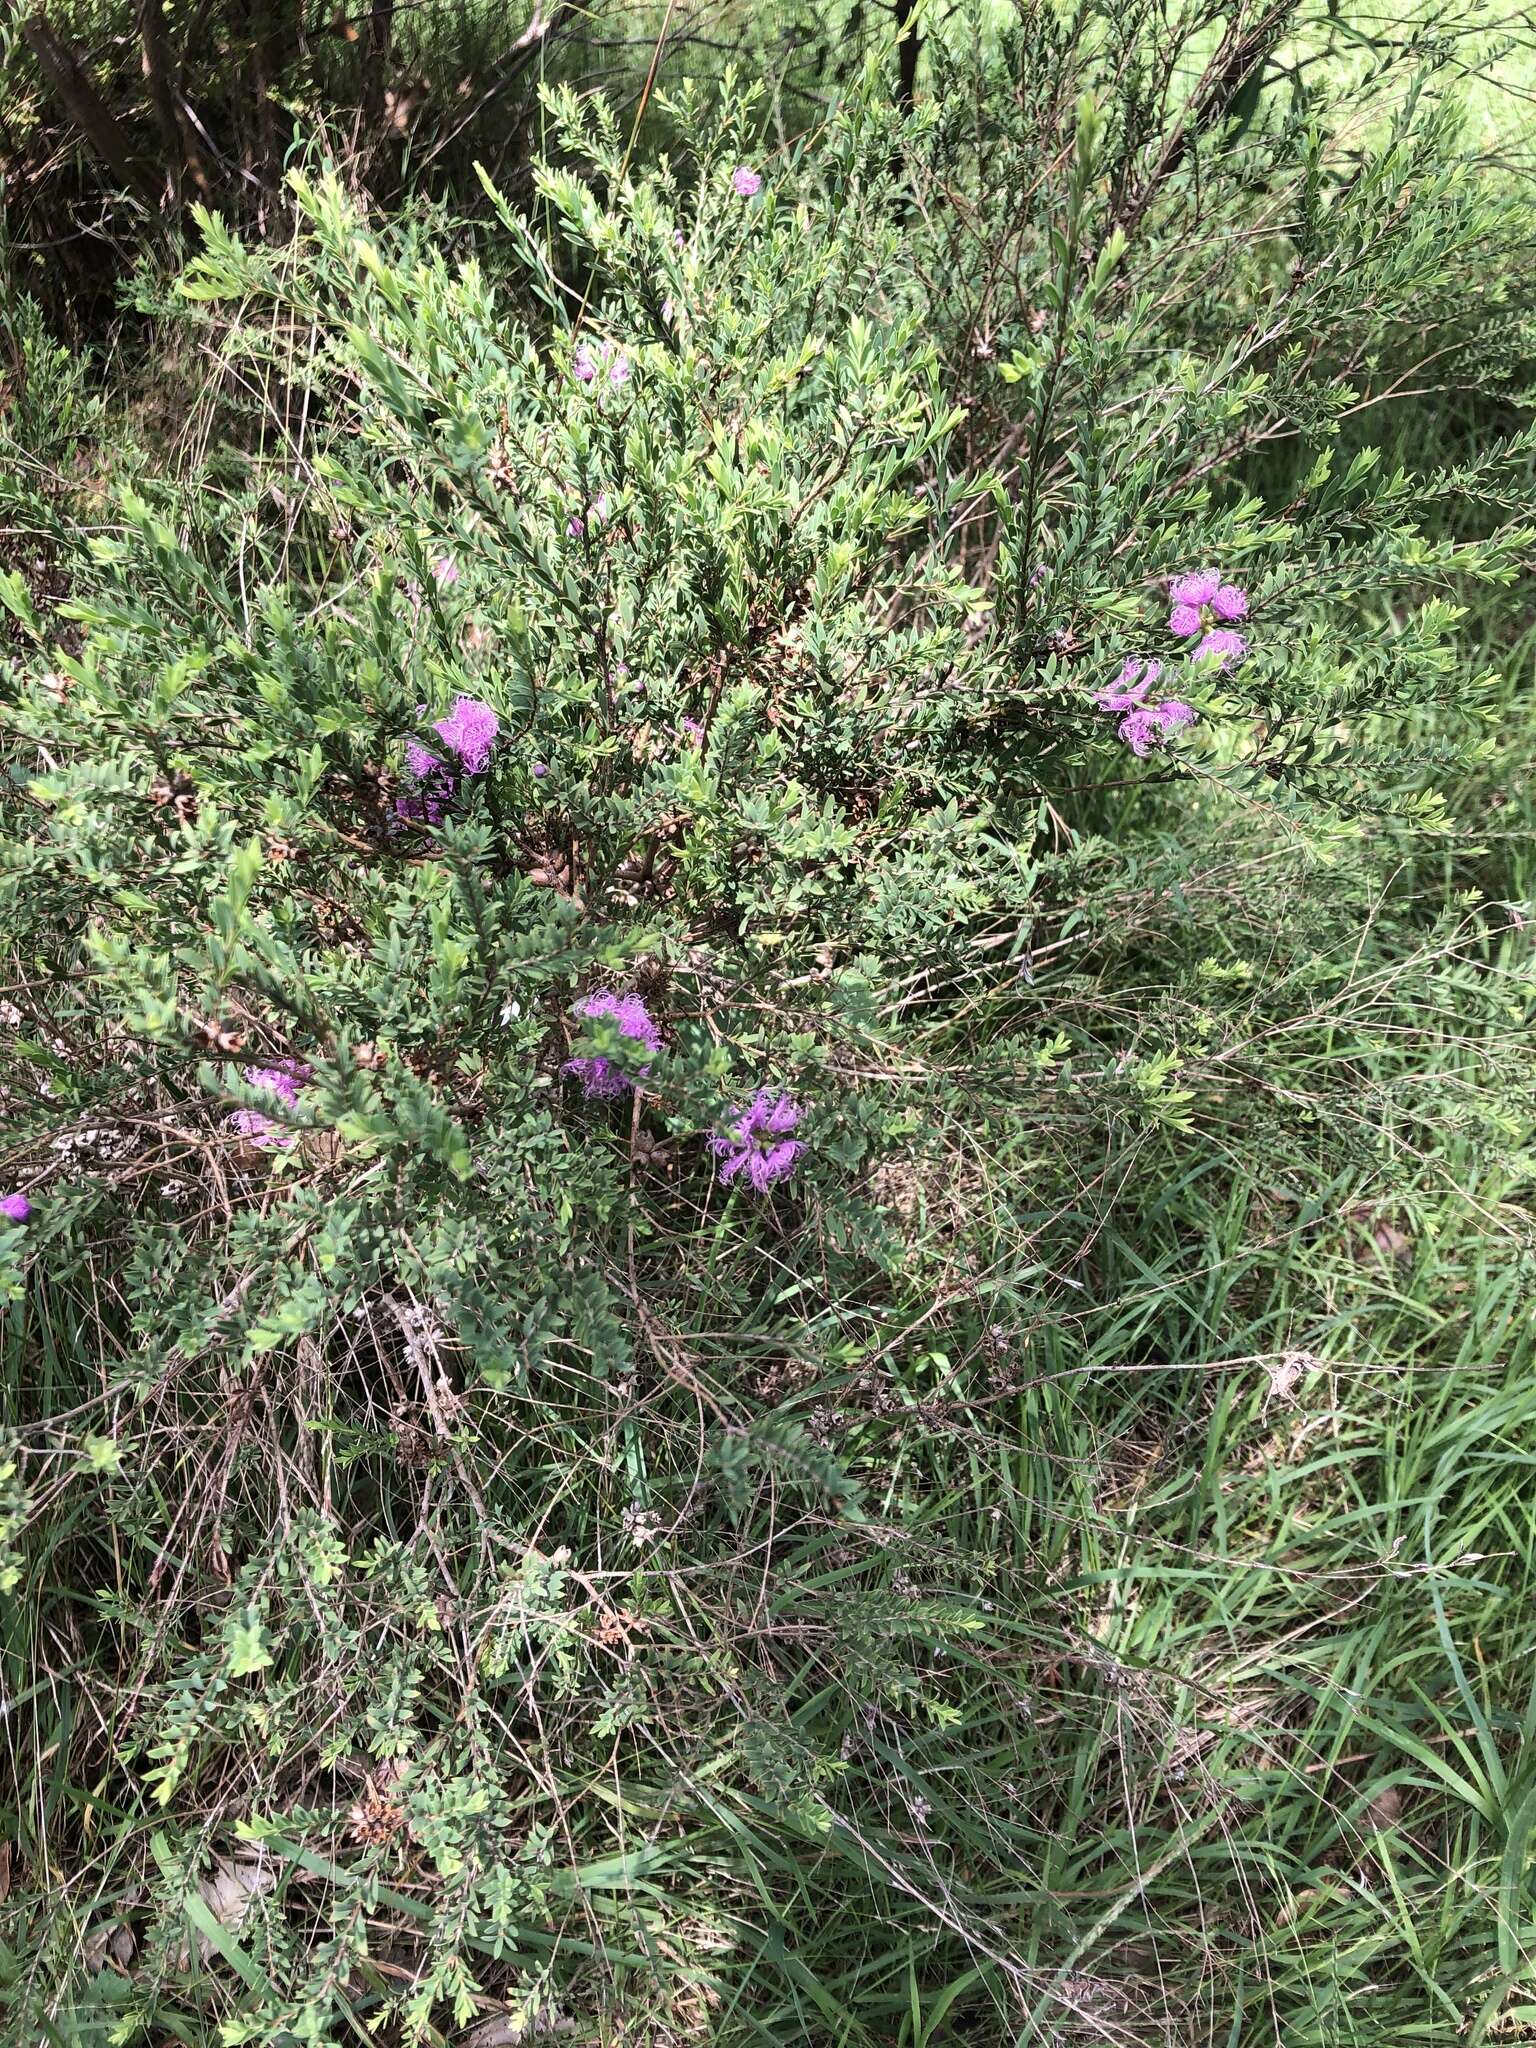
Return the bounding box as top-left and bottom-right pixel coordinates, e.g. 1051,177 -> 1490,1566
0,20 -> 1532,2042
